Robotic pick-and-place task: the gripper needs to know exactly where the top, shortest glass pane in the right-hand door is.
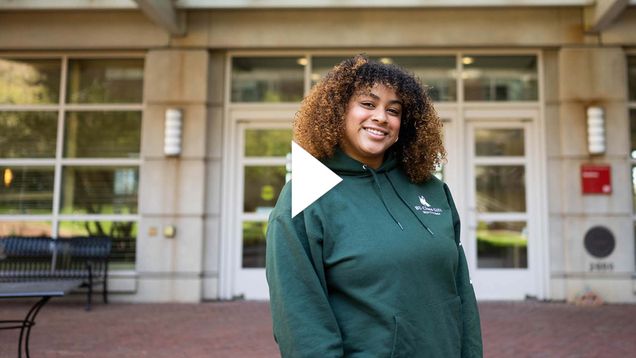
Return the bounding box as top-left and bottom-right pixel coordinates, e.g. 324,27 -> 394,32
475,129 -> 524,156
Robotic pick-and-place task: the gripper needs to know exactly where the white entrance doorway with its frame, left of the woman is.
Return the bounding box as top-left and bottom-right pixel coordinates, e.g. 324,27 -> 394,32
221,109 -> 296,300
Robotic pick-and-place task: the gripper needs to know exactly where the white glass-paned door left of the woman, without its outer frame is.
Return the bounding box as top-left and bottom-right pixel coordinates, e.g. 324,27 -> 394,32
234,121 -> 292,299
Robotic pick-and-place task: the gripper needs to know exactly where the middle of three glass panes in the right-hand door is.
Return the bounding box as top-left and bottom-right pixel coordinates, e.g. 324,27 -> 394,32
475,165 -> 526,212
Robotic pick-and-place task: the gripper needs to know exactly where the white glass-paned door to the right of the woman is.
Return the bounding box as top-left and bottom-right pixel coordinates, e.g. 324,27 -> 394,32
466,117 -> 539,299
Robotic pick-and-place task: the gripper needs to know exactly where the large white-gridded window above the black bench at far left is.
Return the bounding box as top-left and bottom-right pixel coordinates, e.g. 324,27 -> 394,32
0,56 -> 143,269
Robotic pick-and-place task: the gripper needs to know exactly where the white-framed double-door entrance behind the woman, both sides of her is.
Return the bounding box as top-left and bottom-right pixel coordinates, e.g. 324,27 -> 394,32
221,108 -> 545,299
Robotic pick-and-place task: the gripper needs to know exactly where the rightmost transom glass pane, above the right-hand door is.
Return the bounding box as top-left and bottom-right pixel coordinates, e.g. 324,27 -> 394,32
462,55 -> 539,101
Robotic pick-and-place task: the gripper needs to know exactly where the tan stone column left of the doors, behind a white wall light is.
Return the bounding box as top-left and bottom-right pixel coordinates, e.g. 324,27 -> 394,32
133,49 -> 210,302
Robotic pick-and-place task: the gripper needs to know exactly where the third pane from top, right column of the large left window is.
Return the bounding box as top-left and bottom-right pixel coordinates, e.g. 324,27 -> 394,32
61,167 -> 139,214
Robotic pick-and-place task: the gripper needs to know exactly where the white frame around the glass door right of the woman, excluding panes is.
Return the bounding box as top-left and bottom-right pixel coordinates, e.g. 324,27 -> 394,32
462,108 -> 549,300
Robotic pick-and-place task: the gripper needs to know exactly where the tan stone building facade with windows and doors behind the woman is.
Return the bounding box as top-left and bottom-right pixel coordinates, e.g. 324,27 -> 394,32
0,0 -> 636,302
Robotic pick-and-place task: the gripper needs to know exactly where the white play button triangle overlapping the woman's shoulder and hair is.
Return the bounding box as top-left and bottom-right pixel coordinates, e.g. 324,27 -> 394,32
292,141 -> 342,218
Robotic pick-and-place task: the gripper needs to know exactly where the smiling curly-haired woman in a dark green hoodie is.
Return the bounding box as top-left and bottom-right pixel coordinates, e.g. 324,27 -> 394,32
266,56 -> 482,358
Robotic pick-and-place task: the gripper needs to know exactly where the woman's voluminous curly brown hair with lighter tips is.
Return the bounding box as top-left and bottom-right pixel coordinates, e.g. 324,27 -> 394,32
294,55 -> 446,183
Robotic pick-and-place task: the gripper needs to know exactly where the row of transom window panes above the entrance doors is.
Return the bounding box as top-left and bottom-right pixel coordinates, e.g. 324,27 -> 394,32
231,53 -> 539,103
